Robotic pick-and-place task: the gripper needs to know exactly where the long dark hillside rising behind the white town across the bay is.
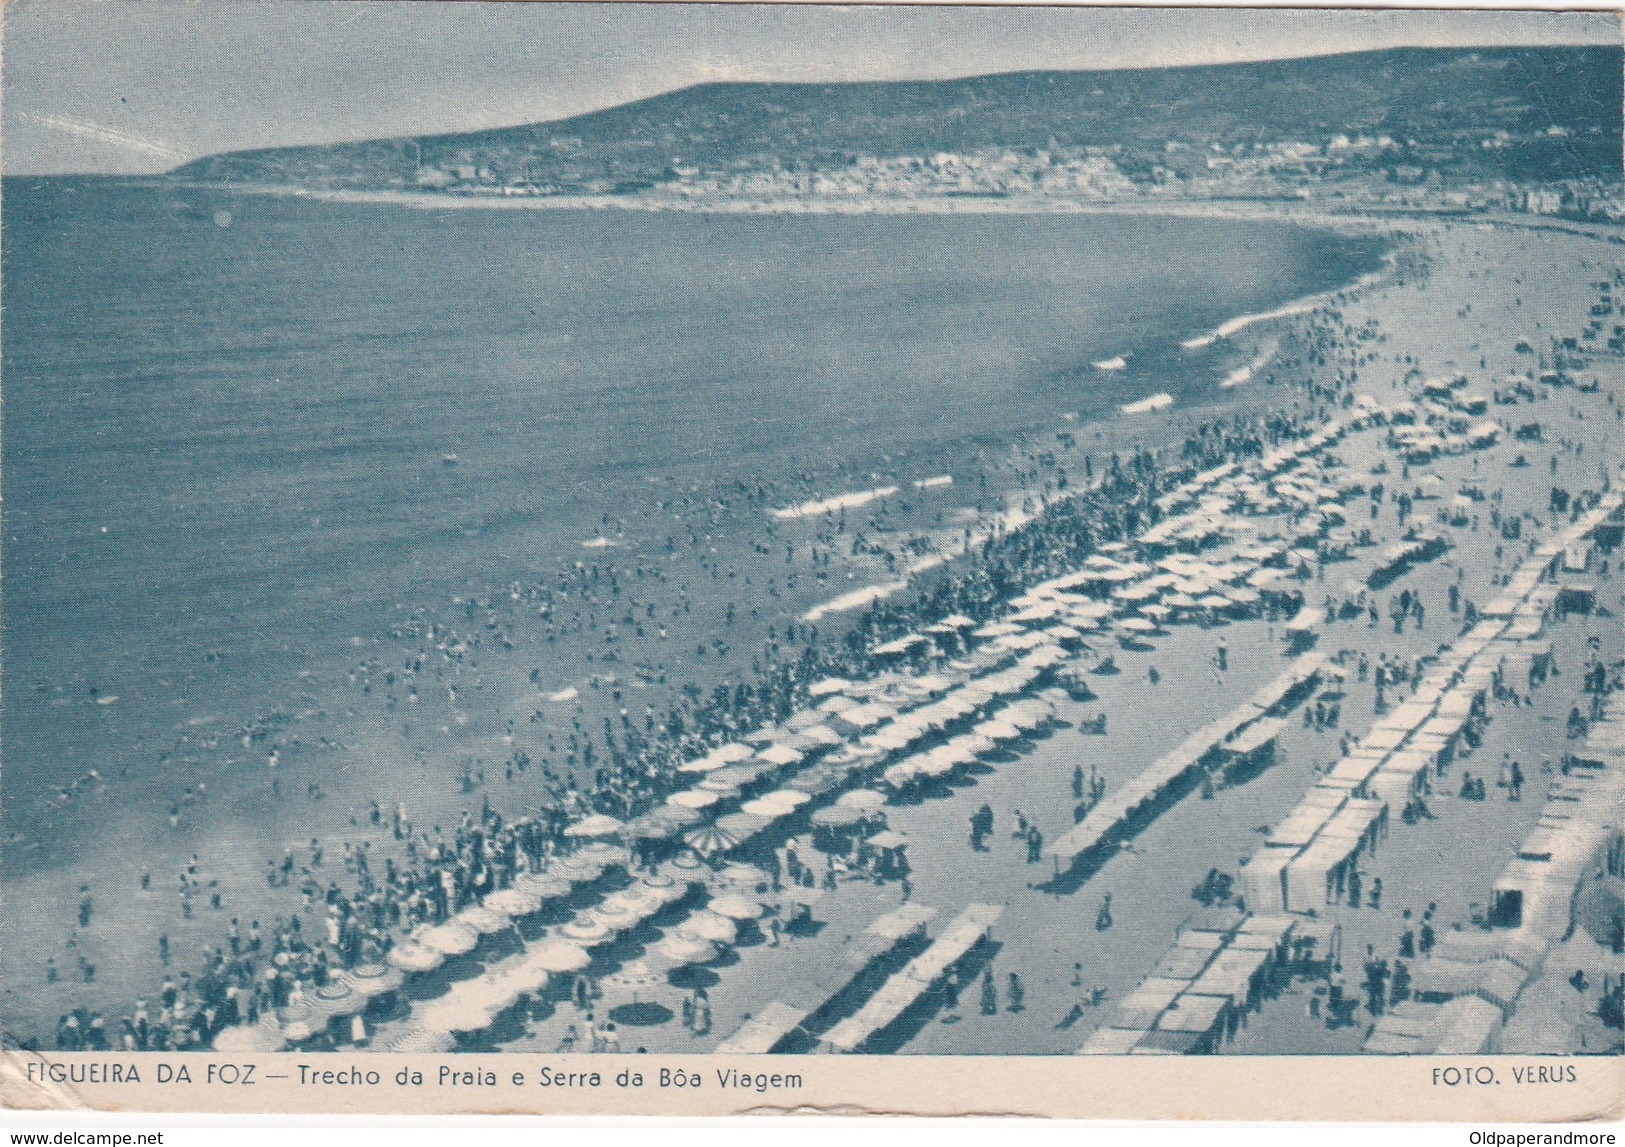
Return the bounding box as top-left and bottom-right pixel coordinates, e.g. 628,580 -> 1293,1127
172,47 -> 1625,192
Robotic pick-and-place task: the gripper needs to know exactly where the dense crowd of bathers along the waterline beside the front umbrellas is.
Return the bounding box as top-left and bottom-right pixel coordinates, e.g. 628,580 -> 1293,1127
34,402 -> 1345,1048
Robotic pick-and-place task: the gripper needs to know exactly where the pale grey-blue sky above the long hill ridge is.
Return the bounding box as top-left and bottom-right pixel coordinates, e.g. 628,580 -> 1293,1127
0,0 -> 1620,174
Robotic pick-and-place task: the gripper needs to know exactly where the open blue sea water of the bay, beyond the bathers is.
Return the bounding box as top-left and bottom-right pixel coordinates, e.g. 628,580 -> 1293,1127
0,179 -> 1380,851
